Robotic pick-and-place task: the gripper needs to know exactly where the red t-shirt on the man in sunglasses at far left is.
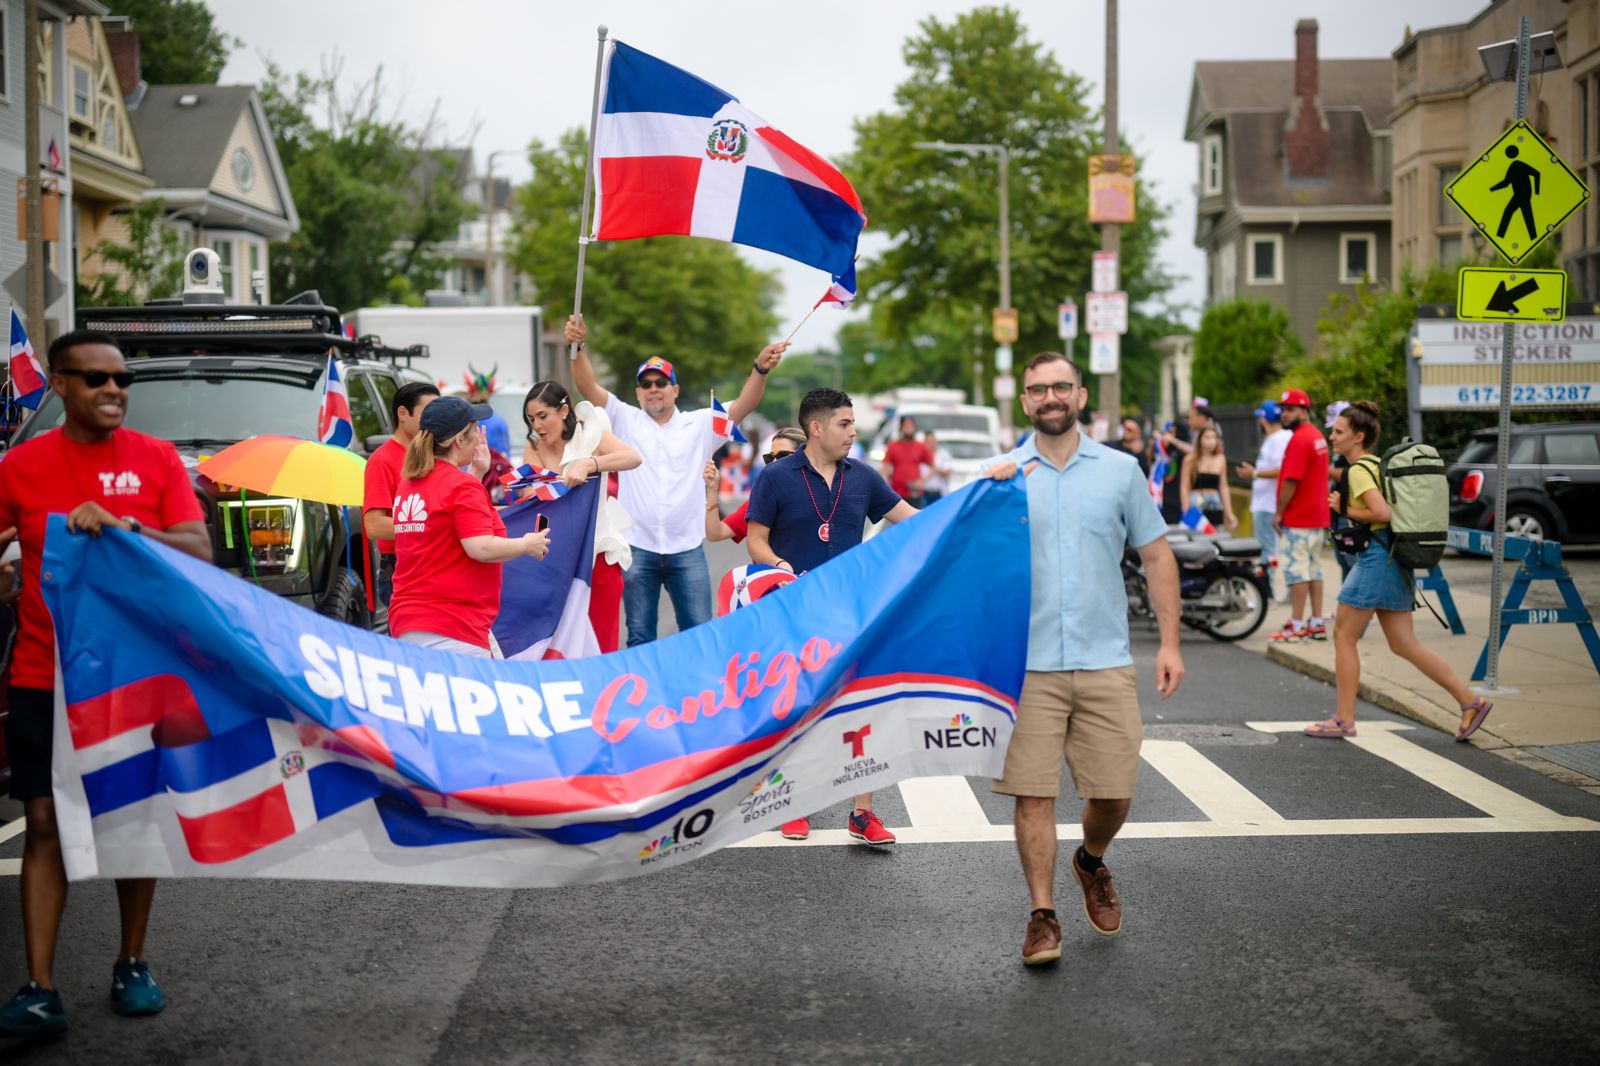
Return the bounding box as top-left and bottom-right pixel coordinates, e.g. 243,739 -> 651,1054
0,429 -> 205,690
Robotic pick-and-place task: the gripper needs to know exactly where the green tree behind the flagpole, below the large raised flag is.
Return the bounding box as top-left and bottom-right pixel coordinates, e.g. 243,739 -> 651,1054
510,130 -> 780,392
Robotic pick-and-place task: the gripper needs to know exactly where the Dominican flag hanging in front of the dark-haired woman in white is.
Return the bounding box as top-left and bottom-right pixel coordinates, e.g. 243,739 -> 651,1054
494,477 -> 605,659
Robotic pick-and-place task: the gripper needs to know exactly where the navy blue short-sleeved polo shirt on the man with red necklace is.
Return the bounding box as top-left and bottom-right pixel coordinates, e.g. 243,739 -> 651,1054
749,448 -> 901,573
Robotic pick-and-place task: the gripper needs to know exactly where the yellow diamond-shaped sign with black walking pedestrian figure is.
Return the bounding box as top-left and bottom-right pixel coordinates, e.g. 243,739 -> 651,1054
1445,122 -> 1589,262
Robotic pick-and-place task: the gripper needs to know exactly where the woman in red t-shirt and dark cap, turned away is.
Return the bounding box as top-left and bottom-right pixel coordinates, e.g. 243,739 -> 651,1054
389,395 -> 550,656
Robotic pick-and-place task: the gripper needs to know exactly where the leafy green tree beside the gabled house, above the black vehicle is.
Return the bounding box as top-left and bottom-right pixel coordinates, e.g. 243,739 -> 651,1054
261,66 -> 477,311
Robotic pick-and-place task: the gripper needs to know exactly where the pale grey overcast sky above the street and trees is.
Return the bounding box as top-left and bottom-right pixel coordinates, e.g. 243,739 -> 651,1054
206,0 -> 1478,340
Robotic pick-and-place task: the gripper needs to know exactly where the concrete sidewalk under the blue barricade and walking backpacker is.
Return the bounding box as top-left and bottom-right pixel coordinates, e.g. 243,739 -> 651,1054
1240,552 -> 1600,795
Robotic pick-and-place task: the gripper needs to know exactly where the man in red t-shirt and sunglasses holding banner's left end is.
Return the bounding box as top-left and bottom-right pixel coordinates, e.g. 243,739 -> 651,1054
0,330 -> 211,1036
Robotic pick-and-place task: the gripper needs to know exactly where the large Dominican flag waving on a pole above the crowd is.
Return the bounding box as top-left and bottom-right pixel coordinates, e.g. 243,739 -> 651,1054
594,40 -> 867,275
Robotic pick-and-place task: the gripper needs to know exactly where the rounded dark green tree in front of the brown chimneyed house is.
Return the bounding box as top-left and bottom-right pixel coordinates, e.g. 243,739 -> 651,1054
1192,299 -> 1304,403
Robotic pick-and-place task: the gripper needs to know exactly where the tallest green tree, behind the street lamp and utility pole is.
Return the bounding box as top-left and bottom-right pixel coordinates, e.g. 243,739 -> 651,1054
845,6 -> 1171,409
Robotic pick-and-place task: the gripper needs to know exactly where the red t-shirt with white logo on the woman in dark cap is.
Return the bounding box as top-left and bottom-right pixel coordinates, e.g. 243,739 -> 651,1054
389,463 -> 506,648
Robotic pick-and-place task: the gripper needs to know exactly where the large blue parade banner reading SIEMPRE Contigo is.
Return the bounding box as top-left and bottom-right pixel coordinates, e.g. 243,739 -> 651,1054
42,479 -> 1029,887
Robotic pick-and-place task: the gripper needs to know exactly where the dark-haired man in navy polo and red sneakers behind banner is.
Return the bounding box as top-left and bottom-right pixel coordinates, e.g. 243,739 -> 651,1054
747,389 -> 917,845
